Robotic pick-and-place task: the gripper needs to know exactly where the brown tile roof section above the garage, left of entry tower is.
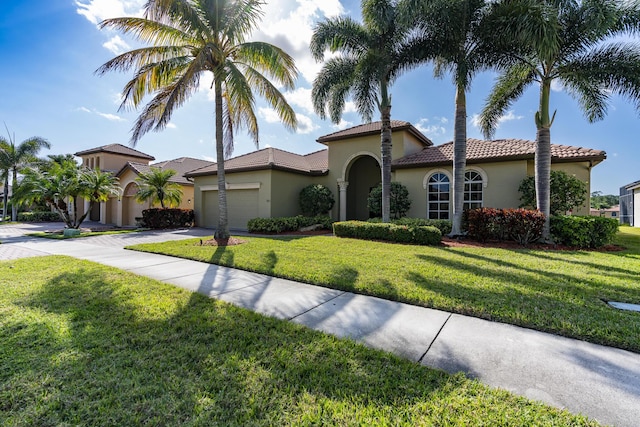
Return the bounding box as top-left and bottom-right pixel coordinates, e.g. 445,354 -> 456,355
185,147 -> 329,177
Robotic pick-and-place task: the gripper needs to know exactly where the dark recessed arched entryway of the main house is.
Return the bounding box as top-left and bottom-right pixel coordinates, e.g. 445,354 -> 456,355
345,155 -> 381,220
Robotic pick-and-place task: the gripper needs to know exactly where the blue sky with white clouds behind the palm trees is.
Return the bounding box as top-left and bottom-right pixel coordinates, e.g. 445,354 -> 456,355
0,0 -> 640,194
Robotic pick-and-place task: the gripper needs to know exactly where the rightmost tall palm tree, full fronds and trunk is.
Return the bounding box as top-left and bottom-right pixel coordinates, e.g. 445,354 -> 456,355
481,0 -> 640,240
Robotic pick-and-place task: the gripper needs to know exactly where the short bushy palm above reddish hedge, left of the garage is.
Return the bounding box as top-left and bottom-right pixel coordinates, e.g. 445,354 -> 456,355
136,167 -> 182,209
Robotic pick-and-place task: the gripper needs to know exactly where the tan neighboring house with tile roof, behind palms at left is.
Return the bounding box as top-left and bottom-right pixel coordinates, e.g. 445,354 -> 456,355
75,144 -> 212,227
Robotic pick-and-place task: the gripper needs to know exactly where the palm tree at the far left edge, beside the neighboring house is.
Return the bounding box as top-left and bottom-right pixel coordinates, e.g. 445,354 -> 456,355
0,129 -> 51,221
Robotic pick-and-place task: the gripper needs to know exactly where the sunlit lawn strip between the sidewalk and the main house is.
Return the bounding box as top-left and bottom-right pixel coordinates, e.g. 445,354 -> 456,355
133,227 -> 640,352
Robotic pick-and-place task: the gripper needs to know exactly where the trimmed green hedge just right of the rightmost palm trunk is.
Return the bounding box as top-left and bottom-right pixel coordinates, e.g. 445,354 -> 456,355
551,215 -> 619,248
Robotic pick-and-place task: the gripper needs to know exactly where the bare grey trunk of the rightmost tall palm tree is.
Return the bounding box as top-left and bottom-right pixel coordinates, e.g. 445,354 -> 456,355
535,79 -> 553,242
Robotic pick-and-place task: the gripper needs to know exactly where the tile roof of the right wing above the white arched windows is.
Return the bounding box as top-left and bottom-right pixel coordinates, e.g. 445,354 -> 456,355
392,138 -> 607,169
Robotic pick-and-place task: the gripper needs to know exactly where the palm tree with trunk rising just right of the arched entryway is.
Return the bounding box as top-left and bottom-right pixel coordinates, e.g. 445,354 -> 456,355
310,0 -> 424,222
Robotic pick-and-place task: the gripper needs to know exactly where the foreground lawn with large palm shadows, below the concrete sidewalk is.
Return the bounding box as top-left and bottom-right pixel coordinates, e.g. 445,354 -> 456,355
0,257 -> 596,426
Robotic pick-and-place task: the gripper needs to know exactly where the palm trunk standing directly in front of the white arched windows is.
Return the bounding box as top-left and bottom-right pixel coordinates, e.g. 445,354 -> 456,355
449,84 -> 467,237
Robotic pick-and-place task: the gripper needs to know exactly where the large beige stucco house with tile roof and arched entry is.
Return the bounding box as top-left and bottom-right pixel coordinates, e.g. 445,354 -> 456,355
186,120 -> 606,229
